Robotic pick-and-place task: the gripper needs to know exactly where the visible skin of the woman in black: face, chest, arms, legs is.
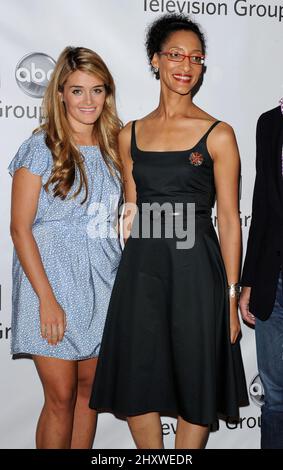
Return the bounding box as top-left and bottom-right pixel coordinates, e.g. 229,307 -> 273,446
119,31 -> 241,449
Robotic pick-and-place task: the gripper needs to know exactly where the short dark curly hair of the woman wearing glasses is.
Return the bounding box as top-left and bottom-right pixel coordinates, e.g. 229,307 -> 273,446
145,14 -> 206,80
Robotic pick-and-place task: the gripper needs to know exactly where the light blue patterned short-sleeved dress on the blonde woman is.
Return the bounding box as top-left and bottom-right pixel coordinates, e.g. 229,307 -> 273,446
9,132 -> 121,360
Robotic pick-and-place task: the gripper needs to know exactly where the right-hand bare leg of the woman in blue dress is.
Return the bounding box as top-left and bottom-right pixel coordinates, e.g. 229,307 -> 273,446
71,358 -> 97,449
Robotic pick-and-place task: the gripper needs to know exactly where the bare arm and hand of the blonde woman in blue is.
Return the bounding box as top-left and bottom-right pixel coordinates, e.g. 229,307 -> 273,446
11,168 -> 65,344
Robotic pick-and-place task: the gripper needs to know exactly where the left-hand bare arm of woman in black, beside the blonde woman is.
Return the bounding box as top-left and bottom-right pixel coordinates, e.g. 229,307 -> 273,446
119,123 -> 137,243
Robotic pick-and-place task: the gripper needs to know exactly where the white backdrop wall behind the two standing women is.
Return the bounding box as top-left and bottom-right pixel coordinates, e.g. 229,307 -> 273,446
0,0 -> 283,449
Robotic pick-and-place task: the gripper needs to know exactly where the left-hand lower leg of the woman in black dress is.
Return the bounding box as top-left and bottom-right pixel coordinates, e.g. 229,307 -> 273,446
127,413 -> 163,449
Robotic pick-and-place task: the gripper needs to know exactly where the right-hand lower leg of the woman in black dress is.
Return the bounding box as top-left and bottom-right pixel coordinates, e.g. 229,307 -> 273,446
175,416 -> 209,449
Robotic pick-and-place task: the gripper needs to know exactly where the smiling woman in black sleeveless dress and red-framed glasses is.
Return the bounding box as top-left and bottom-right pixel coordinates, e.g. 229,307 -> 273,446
90,15 -> 247,449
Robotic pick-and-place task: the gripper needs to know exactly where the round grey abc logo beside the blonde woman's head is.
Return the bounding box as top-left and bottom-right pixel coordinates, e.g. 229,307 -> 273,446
15,52 -> 55,98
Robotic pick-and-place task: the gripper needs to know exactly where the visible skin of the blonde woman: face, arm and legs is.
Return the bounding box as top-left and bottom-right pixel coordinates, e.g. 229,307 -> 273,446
11,71 -> 105,449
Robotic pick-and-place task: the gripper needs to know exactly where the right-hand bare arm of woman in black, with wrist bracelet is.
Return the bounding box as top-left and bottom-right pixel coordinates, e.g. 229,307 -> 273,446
208,123 -> 241,343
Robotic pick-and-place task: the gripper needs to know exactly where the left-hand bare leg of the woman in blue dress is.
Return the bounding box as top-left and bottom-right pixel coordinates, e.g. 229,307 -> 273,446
33,356 -> 77,449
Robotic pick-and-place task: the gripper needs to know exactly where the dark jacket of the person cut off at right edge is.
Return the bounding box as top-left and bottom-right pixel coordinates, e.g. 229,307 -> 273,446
241,106 -> 283,320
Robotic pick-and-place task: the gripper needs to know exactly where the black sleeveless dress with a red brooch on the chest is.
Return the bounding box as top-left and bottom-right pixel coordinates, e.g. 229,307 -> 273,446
90,121 -> 248,425
